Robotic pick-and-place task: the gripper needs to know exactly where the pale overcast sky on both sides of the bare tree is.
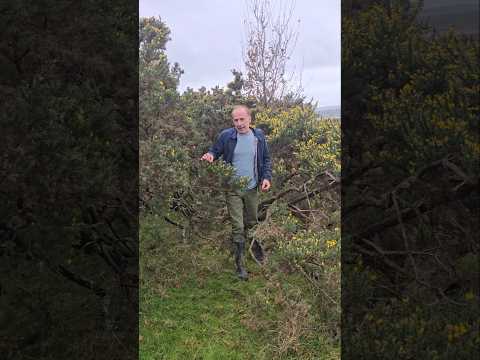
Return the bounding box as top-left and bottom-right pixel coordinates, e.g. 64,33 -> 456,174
140,0 -> 340,106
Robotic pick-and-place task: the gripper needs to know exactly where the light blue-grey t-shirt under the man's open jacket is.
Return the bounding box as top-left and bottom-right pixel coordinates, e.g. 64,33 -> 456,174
232,131 -> 257,189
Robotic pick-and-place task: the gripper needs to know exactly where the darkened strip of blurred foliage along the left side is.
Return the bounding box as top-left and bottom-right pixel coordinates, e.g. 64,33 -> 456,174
0,0 -> 138,359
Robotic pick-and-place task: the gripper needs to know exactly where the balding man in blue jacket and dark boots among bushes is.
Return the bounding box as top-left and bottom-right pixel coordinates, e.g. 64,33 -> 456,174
201,105 -> 272,280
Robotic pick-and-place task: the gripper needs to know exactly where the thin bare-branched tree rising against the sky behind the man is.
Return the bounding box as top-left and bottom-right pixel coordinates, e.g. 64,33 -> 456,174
243,0 -> 301,106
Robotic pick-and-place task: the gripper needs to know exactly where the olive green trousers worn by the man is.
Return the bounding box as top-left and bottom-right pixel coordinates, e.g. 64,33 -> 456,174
226,187 -> 258,243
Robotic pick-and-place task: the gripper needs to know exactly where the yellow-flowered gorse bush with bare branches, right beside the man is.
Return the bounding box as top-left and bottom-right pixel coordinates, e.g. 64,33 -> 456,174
251,104 -> 341,338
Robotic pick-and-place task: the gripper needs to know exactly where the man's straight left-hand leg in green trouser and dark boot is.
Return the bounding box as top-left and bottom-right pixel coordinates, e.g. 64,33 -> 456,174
226,191 -> 248,280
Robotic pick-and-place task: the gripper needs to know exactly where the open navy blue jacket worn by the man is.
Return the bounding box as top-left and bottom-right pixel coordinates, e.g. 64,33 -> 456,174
208,127 -> 272,184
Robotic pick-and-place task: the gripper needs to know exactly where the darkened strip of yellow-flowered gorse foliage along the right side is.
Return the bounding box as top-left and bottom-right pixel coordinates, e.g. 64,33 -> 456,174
342,0 -> 480,359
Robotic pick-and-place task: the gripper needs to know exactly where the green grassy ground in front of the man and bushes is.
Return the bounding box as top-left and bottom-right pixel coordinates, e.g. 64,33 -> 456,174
140,218 -> 339,360
